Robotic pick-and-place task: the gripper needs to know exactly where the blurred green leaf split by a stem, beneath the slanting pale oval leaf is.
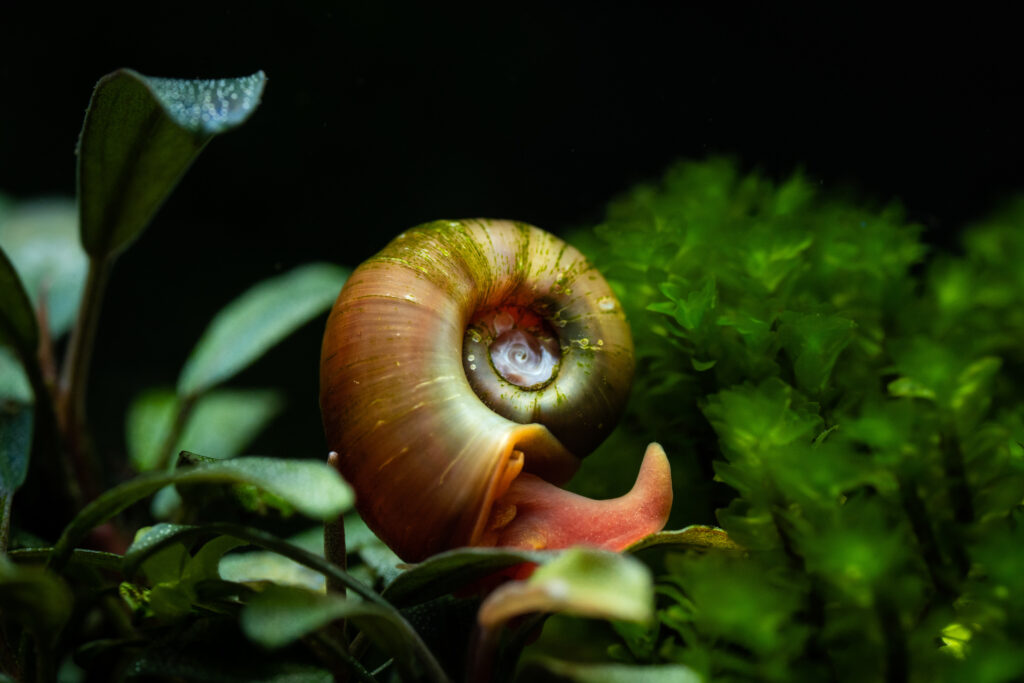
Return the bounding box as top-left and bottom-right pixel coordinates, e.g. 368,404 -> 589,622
131,389 -> 284,472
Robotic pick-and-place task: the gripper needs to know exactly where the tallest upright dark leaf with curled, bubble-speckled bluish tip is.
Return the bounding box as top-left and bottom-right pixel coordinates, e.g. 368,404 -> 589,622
78,69 -> 266,258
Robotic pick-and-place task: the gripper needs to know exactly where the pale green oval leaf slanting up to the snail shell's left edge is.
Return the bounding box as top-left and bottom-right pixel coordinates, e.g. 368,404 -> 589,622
178,263 -> 348,397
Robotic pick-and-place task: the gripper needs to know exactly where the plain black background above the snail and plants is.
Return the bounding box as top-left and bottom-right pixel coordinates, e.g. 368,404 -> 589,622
0,2 -> 1024,471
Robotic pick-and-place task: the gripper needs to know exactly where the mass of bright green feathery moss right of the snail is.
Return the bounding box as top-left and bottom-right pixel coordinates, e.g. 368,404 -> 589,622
572,160 -> 1024,681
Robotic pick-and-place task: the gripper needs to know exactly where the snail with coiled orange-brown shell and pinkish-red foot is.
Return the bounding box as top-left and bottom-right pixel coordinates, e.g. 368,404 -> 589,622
321,219 -> 672,561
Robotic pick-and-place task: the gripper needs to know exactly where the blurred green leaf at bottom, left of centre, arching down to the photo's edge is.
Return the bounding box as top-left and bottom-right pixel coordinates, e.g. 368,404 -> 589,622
241,586 -> 447,681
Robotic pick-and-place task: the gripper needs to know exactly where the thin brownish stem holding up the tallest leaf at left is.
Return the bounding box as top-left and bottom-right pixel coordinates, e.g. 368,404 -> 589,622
57,256 -> 113,500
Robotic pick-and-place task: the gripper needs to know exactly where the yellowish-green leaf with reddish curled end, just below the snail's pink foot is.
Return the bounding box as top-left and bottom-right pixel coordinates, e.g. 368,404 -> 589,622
477,548 -> 654,629
